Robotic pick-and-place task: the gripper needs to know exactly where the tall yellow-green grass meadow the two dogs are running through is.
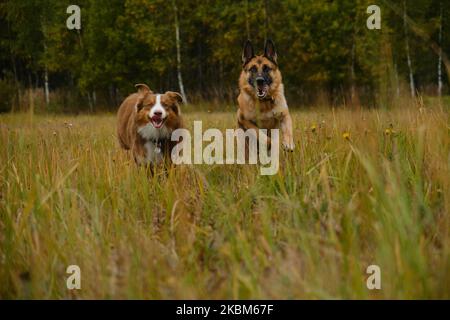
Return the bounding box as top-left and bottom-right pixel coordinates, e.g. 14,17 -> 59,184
0,100 -> 450,299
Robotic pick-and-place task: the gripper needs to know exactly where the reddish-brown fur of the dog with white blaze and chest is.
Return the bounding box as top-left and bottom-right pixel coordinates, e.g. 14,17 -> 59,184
117,85 -> 183,164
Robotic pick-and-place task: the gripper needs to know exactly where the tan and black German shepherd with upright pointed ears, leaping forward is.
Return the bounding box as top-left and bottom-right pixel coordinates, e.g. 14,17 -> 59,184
237,40 -> 294,151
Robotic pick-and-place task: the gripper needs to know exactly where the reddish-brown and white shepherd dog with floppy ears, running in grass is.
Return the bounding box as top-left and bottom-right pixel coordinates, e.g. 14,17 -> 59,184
117,84 -> 183,165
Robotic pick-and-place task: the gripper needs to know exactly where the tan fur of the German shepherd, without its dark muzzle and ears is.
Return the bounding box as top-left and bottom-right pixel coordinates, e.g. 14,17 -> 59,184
237,56 -> 294,151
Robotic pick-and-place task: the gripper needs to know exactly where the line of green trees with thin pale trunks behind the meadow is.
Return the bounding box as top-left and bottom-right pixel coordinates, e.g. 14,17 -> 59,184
0,0 -> 450,111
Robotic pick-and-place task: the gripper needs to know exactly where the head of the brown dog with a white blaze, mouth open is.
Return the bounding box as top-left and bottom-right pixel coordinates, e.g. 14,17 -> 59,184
136,91 -> 182,139
